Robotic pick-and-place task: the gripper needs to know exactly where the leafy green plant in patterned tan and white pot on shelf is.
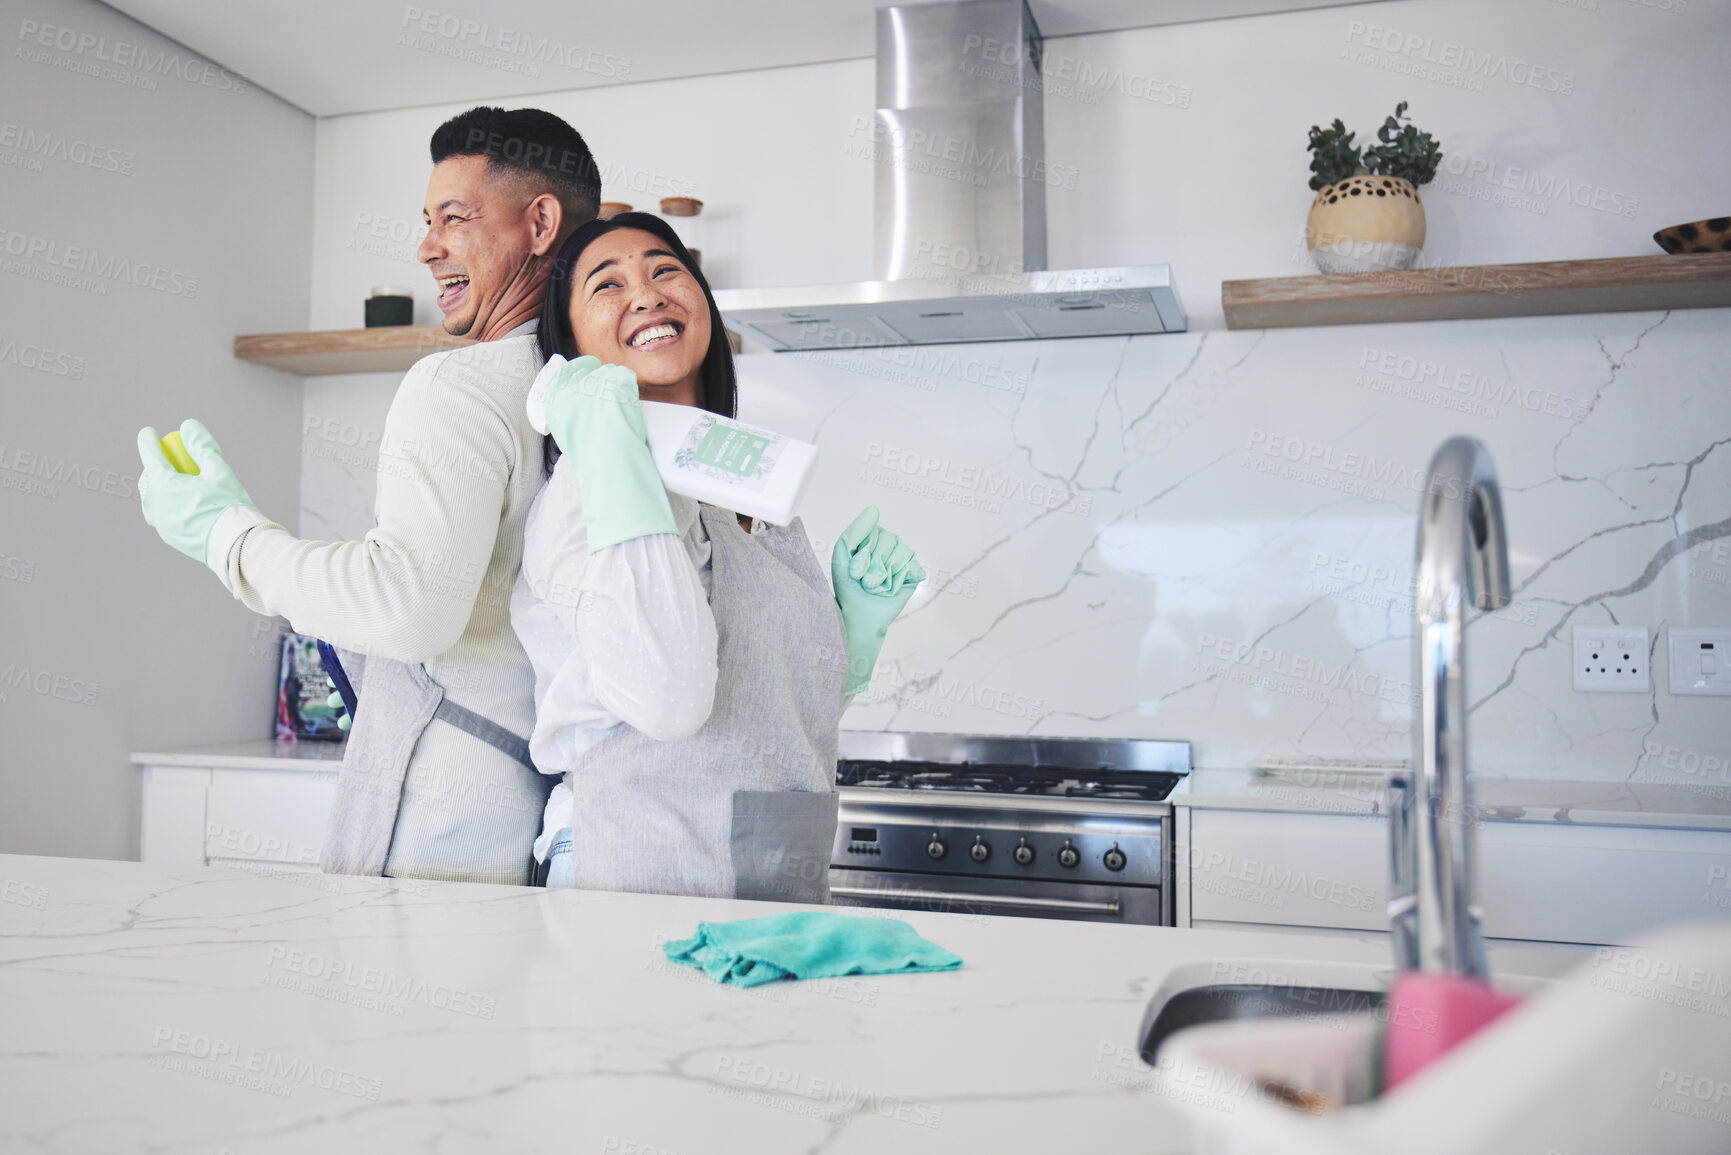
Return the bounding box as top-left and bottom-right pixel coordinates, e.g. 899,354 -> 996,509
1303,100 -> 1442,274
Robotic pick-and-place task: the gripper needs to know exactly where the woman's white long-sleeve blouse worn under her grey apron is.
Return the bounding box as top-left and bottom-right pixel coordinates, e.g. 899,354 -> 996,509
511,457 -> 717,859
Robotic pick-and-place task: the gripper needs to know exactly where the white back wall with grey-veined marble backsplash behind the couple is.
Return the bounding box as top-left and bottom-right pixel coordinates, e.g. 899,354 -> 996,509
303,0 -> 1731,797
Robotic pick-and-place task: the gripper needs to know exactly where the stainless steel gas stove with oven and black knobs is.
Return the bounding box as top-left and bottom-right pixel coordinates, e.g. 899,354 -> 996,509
829,731 -> 1189,925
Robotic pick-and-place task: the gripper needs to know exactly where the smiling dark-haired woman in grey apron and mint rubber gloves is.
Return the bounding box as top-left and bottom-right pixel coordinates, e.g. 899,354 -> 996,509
512,213 -> 924,902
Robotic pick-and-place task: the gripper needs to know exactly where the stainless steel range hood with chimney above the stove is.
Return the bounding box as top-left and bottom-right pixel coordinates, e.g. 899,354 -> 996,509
715,0 -> 1186,352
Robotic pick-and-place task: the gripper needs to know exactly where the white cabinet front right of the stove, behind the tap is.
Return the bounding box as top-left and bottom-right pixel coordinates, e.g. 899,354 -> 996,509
1184,809 -> 1731,945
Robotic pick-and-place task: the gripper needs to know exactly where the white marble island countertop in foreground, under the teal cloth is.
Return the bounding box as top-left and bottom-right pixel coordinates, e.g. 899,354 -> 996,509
0,855 -> 1572,1155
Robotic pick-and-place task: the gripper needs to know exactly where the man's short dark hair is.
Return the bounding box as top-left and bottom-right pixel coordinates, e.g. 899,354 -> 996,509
431,106 -> 601,227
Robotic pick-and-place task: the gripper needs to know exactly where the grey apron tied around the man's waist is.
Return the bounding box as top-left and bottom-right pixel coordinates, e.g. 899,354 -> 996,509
319,651 -> 545,876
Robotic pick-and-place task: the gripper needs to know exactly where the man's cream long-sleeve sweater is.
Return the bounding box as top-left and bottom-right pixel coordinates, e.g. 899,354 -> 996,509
211,322 -> 547,734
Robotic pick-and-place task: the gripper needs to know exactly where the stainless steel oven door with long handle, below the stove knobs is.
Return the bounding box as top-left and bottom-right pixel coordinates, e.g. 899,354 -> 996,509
829,866 -> 1172,926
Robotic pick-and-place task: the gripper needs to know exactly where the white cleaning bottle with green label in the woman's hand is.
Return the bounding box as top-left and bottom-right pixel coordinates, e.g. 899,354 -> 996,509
526,353 -> 817,525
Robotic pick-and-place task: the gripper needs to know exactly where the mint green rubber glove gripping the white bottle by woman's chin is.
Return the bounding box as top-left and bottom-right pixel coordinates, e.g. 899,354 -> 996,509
542,357 -> 679,552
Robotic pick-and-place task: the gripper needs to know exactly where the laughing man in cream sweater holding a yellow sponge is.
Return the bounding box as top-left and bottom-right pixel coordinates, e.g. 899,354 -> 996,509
138,107 -> 601,883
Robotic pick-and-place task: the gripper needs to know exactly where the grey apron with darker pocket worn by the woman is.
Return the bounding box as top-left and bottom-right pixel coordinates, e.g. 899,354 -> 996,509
566,506 -> 848,902
